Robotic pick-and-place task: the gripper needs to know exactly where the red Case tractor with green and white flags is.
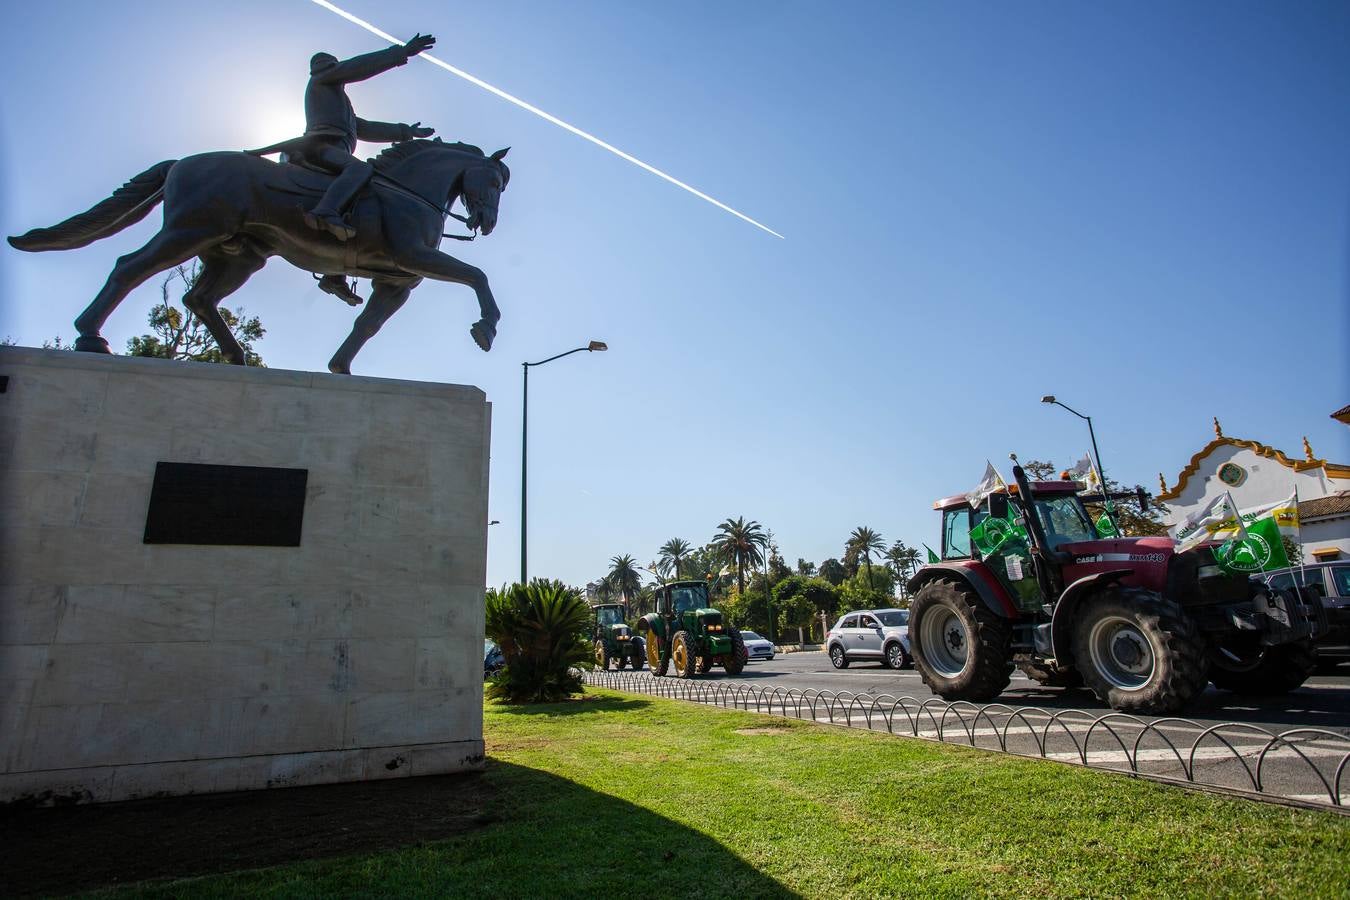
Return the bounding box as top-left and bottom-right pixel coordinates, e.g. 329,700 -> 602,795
909,457 -> 1326,714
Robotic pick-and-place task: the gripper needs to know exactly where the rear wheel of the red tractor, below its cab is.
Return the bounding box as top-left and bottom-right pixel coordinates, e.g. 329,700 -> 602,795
910,579 -> 1013,703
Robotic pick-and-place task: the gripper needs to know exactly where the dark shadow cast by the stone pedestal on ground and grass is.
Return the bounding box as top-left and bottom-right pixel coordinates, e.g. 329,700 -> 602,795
0,760 -> 797,899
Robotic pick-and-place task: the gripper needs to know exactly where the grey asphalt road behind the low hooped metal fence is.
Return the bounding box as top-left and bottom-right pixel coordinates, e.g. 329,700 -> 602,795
598,650 -> 1350,810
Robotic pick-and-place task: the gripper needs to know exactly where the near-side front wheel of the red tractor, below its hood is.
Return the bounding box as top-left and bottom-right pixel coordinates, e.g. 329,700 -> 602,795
1073,586 -> 1210,715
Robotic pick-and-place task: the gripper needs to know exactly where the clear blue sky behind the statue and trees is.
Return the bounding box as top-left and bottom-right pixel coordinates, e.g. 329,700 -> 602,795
0,0 -> 1350,584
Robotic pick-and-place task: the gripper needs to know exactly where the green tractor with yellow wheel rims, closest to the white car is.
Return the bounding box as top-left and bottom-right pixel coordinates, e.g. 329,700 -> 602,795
637,582 -> 749,679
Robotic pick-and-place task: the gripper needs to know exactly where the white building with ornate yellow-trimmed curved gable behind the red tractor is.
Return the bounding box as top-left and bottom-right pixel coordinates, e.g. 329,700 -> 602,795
1157,406 -> 1350,563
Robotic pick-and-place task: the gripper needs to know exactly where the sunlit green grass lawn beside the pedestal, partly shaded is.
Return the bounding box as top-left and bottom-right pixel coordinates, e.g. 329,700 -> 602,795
97,691 -> 1350,899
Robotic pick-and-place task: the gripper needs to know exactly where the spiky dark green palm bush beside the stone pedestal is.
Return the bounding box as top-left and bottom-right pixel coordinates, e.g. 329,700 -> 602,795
486,579 -> 594,703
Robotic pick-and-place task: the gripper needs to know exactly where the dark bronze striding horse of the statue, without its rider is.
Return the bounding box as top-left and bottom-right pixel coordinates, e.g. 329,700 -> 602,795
9,139 -> 510,375
